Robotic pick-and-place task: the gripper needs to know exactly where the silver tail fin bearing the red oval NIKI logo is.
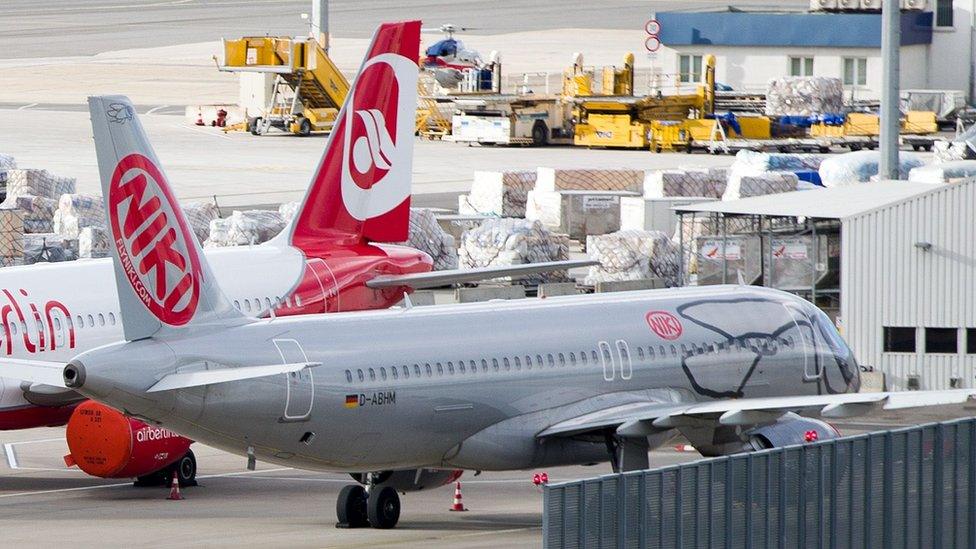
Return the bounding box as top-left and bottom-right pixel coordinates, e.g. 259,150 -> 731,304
88,96 -> 246,341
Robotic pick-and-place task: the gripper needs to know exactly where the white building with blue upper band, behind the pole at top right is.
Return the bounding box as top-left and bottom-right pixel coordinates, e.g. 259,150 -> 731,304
654,0 -> 974,100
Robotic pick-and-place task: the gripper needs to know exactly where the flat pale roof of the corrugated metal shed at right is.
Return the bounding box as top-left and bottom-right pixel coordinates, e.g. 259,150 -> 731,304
672,181 -> 941,219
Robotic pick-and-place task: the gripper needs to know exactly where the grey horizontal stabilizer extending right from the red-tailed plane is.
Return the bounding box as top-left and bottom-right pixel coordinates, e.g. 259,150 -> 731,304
366,259 -> 600,290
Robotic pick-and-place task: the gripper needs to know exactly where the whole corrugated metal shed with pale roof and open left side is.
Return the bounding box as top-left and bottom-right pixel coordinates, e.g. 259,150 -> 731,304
679,180 -> 976,390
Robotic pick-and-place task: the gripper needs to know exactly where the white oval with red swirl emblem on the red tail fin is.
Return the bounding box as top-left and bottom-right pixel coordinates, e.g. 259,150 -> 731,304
341,53 -> 417,221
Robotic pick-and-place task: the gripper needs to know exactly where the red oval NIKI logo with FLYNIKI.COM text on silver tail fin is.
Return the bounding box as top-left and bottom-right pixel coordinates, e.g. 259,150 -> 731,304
108,154 -> 202,326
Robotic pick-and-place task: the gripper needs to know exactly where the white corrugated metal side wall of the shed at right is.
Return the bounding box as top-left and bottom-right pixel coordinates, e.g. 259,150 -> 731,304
841,182 -> 976,389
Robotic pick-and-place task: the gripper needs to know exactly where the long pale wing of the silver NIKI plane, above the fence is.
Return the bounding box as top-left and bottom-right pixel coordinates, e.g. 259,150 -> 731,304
537,389 -> 976,437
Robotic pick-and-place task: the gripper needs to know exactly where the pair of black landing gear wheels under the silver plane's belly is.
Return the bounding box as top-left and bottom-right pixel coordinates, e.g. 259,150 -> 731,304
336,473 -> 400,529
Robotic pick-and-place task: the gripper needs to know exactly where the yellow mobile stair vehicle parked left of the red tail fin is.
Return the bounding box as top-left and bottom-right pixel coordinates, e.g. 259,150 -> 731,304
218,36 -> 349,135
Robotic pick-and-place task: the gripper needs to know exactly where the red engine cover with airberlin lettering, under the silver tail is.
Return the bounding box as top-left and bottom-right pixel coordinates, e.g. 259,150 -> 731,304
65,400 -> 193,478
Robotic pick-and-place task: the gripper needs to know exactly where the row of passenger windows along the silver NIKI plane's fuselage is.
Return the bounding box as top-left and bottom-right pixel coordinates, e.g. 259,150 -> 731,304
345,336 -> 795,383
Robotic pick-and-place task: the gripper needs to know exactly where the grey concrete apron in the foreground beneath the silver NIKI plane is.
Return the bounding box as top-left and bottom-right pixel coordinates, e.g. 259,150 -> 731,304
0,406 -> 974,549
